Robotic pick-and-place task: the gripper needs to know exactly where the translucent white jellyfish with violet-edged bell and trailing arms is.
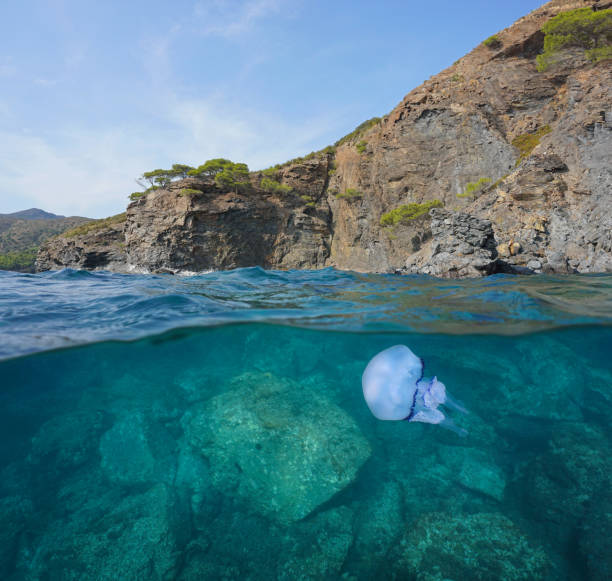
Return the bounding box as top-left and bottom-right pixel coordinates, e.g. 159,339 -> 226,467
361,345 -> 468,436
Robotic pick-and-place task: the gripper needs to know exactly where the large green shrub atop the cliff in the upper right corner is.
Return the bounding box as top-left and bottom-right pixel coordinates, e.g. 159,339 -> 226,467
536,8 -> 612,71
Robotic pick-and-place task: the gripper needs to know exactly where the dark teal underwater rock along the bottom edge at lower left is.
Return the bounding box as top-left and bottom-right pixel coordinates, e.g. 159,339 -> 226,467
18,484 -> 189,581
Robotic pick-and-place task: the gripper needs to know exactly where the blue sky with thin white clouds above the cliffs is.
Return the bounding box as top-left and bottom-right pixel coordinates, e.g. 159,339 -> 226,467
0,0 -> 543,218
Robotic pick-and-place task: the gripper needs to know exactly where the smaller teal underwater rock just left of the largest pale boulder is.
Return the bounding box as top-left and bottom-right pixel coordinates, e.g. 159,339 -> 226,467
100,413 -> 176,485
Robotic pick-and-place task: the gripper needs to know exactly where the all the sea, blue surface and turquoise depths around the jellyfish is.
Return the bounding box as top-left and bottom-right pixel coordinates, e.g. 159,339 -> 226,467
0,268 -> 612,581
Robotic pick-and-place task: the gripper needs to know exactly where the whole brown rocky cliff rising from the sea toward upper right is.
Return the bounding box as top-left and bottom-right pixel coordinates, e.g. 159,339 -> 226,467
39,0 -> 612,276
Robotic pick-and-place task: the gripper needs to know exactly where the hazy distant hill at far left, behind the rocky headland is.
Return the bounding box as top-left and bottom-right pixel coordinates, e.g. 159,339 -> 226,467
0,208 -> 91,272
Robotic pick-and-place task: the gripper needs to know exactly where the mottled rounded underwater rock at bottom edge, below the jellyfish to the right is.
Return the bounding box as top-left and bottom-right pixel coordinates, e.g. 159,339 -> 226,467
391,513 -> 549,581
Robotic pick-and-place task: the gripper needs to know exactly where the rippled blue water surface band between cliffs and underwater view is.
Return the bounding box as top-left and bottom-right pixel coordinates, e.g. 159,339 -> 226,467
0,267 -> 612,358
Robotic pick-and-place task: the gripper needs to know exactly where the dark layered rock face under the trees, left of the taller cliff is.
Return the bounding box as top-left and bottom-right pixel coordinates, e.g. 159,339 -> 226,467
125,171 -> 330,272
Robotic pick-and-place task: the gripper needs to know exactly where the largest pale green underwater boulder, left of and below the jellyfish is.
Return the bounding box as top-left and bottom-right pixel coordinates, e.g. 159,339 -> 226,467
183,373 -> 370,522
